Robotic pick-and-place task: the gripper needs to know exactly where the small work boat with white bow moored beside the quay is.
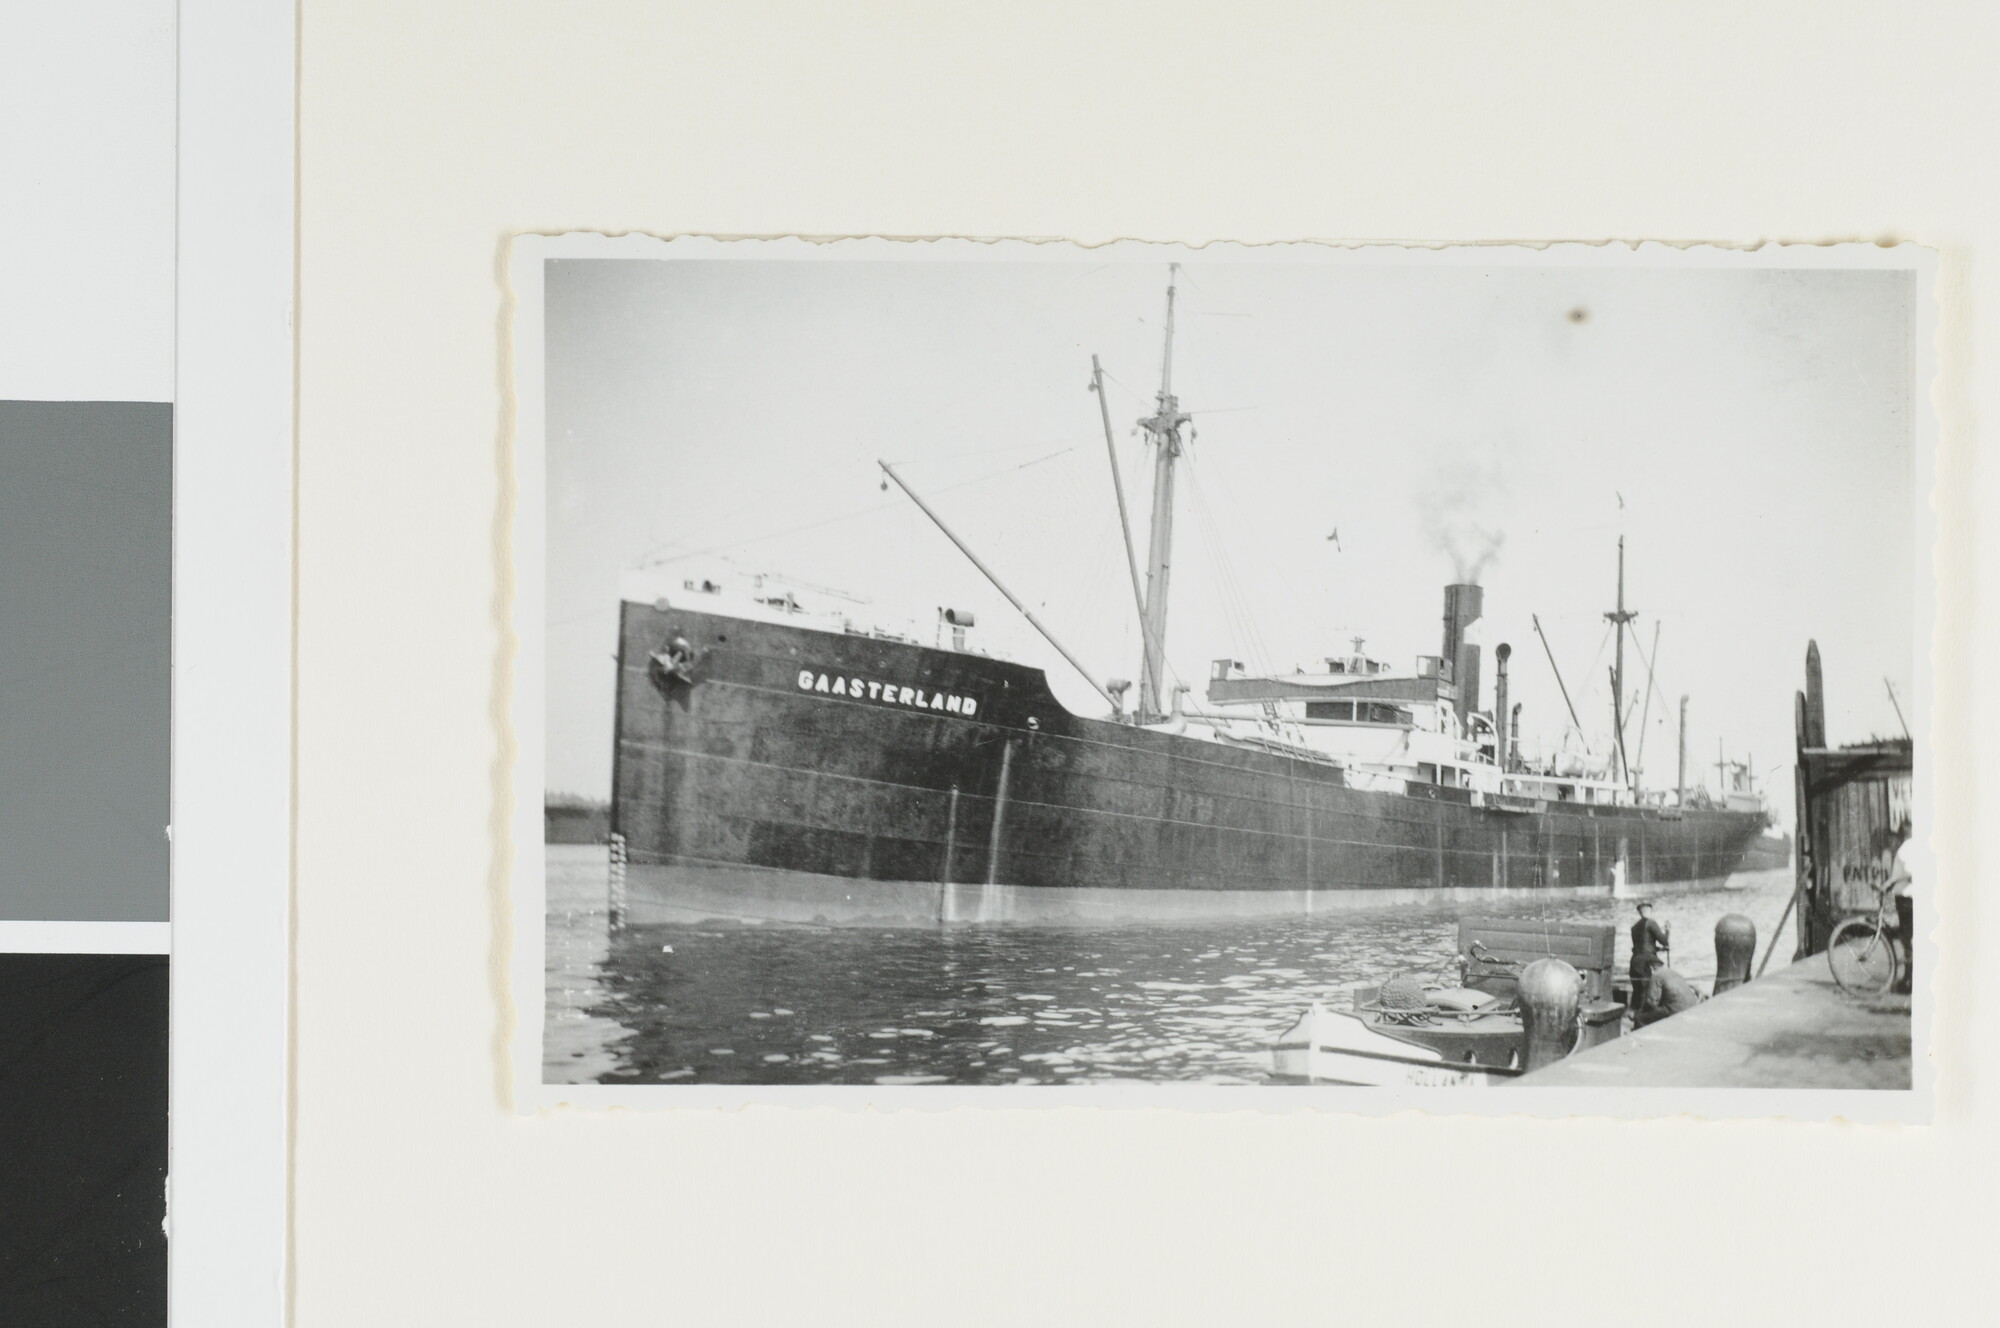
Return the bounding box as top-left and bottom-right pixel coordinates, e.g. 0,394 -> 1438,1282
1272,918 -> 1626,1088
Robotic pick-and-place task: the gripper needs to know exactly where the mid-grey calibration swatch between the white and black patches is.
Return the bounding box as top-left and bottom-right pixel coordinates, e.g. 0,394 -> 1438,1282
0,402 -> 172,922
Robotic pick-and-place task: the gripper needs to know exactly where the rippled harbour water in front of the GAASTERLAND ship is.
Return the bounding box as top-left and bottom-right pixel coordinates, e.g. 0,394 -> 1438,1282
542,844 -> 1792,1084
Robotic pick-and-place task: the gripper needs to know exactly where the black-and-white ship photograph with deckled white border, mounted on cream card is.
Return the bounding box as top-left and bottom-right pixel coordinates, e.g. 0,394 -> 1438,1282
512,236 -> 1936,1114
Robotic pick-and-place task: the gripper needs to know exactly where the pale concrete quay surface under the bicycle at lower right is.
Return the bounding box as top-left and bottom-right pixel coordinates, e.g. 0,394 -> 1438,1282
1512,954 -> 1910,1088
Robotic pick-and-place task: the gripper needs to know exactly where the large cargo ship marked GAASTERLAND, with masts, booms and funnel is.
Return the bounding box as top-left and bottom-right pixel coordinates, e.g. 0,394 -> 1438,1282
610,264 -> 1766,926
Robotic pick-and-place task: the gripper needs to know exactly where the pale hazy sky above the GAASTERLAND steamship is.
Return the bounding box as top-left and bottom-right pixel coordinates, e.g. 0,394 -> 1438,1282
544,250 -> 1916,822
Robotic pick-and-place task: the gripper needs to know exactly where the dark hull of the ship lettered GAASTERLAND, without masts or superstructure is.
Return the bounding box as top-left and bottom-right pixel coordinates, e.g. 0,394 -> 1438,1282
612,602 -> 1764,926
